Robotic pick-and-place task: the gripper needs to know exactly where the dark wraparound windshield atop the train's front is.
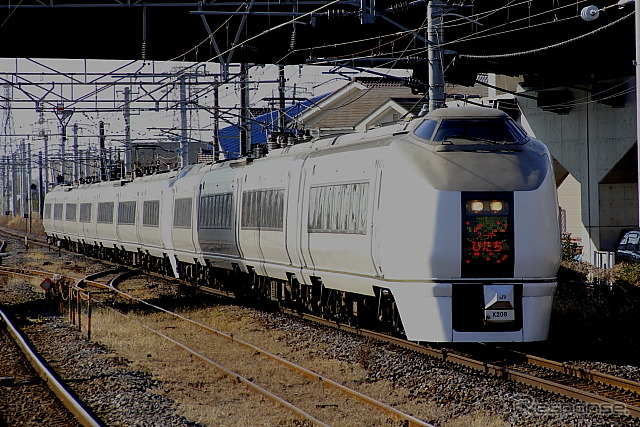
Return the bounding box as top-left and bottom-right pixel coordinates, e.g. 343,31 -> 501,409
416,118 -> 529,144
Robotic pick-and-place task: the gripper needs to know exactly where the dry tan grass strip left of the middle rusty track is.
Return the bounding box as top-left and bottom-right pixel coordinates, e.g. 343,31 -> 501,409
93,309 -> 299,426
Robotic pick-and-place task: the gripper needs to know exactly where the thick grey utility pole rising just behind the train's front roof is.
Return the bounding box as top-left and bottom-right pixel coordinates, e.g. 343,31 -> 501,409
427,0 -> 445,111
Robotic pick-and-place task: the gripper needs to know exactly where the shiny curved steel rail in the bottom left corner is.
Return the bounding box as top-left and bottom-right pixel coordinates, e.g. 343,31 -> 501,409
0,310 -> 104,427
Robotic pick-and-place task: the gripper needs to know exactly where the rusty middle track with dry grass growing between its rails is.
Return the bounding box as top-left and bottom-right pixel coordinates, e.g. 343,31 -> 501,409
72,271 -> 431,427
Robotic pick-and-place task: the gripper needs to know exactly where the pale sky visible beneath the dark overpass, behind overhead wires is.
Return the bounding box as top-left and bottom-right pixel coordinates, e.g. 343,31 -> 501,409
0,58 -> 406,164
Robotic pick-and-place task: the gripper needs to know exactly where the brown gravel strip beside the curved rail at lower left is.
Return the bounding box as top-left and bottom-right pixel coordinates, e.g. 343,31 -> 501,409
0,244 -> 200,426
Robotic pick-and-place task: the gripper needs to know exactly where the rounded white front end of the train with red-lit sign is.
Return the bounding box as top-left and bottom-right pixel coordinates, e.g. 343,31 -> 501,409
379,107 -> 561,342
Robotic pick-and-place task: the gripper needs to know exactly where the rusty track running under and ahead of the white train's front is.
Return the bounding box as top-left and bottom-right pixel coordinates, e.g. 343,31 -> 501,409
3,227 -> 640,424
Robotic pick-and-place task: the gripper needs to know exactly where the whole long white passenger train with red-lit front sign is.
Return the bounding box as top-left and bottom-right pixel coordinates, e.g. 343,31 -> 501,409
44,107 -> 561,342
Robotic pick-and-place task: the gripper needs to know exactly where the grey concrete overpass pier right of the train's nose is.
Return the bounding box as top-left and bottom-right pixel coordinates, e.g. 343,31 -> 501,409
518,82 -> 638,254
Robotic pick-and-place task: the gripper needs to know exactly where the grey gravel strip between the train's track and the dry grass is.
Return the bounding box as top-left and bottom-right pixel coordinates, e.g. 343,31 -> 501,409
257,313 -> 640,426
